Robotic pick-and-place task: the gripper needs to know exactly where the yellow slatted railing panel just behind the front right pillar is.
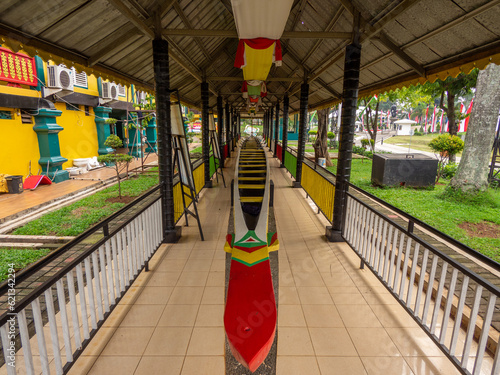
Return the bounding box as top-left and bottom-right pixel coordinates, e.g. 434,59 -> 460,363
302,163 -> 335,222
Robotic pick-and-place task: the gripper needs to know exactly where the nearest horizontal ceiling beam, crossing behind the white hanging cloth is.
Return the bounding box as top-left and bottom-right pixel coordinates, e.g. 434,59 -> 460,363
161,29 -> 352,39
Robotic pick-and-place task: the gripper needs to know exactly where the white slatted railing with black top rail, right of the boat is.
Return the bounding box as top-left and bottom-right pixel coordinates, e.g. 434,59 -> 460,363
343,193 -> 500,375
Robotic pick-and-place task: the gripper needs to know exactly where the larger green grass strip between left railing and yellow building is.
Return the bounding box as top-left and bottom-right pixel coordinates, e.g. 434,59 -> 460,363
13,175 -> 158,236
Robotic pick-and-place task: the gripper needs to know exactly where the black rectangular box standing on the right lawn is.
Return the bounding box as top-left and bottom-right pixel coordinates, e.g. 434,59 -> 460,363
372,154 -> 438,187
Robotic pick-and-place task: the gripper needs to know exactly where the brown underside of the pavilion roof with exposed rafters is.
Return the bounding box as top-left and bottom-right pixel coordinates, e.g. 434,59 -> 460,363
0,0 -> 500,111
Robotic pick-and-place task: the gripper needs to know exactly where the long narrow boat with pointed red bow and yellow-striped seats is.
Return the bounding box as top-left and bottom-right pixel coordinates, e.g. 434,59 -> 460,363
224,137 -> 279,372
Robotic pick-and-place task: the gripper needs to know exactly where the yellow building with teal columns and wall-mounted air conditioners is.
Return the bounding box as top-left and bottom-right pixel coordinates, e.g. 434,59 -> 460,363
0,46 -> 156,182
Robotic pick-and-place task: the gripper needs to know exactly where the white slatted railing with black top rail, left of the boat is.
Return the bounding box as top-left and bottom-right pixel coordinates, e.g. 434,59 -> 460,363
0,198 -> 162,375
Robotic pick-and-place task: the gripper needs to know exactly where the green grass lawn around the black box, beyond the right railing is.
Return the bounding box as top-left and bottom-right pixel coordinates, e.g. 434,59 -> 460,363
329,159 -> 500,262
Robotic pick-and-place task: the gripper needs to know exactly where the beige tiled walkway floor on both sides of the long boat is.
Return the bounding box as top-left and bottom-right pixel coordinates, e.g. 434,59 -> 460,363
65,151 -> 464,375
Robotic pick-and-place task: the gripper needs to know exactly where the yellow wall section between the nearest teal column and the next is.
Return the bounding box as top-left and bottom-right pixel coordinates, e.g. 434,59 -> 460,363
56,103 -> 99,169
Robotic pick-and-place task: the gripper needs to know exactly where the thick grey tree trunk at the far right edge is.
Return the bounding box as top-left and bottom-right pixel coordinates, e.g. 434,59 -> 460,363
450,63 -> 500,192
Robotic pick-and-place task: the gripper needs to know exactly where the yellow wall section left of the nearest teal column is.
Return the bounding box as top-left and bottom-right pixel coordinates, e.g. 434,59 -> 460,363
0,107 -> 40,177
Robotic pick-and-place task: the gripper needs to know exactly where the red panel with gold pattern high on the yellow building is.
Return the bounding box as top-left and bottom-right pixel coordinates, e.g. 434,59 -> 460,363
0,48 -> 38,86
